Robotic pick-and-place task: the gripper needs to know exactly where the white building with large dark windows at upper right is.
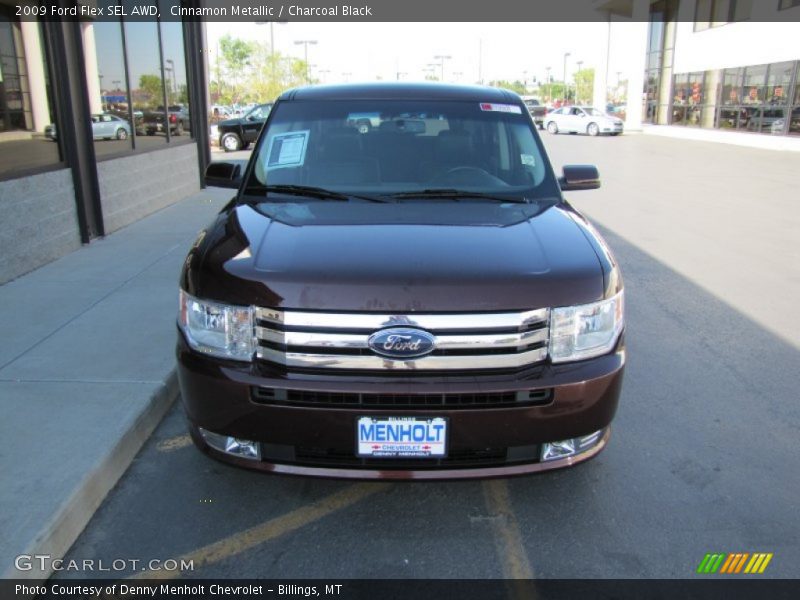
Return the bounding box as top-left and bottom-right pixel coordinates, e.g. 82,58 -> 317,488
593,0 -> 800,140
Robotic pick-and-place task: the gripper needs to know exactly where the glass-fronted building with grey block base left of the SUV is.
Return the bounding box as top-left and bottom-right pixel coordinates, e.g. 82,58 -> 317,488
0,0 -> 209,284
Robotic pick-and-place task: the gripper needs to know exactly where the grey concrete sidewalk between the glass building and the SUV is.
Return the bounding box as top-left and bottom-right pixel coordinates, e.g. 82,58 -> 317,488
0,189 -> 232,579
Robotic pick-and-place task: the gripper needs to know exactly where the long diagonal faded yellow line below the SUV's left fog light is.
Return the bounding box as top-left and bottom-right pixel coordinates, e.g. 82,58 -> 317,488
133,483 -> 389,579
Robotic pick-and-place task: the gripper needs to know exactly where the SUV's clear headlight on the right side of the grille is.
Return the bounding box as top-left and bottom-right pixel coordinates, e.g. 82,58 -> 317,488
550,291 -> 624,362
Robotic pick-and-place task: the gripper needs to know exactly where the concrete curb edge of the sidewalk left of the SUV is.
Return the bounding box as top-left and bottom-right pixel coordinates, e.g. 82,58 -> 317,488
3,368 -> 179,582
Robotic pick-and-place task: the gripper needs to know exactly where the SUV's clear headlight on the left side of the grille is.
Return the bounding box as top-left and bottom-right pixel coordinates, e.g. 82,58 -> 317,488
178,290 -> 255,361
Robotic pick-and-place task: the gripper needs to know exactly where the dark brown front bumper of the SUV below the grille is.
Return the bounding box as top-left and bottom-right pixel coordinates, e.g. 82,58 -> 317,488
177,333 -> 625,479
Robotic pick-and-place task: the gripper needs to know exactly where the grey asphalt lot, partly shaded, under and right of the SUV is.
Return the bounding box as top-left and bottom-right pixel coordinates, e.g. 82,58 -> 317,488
60,133 -> 800,579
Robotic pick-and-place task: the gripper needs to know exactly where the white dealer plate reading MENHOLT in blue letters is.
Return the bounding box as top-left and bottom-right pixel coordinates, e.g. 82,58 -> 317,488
356,417 -> 447,458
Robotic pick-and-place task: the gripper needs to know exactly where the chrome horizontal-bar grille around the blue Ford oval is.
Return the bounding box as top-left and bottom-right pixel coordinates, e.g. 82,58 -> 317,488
256,308 -> 549,371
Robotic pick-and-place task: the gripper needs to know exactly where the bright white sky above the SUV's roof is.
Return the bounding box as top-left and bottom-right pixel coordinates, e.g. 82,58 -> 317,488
207,22 -> 644,90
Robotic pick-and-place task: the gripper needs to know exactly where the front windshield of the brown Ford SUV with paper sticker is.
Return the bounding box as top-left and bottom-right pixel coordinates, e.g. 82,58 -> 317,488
244,100 -> 559,203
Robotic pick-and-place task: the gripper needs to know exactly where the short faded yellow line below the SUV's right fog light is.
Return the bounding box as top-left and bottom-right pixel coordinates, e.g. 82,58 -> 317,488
483,479 -> 533,580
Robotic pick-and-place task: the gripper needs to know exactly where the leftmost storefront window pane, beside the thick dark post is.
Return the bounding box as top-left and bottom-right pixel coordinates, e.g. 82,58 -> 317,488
0,4 -> 61,178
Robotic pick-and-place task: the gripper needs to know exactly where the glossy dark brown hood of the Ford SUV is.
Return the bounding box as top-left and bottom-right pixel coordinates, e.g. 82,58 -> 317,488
192,202 -> 604,313
